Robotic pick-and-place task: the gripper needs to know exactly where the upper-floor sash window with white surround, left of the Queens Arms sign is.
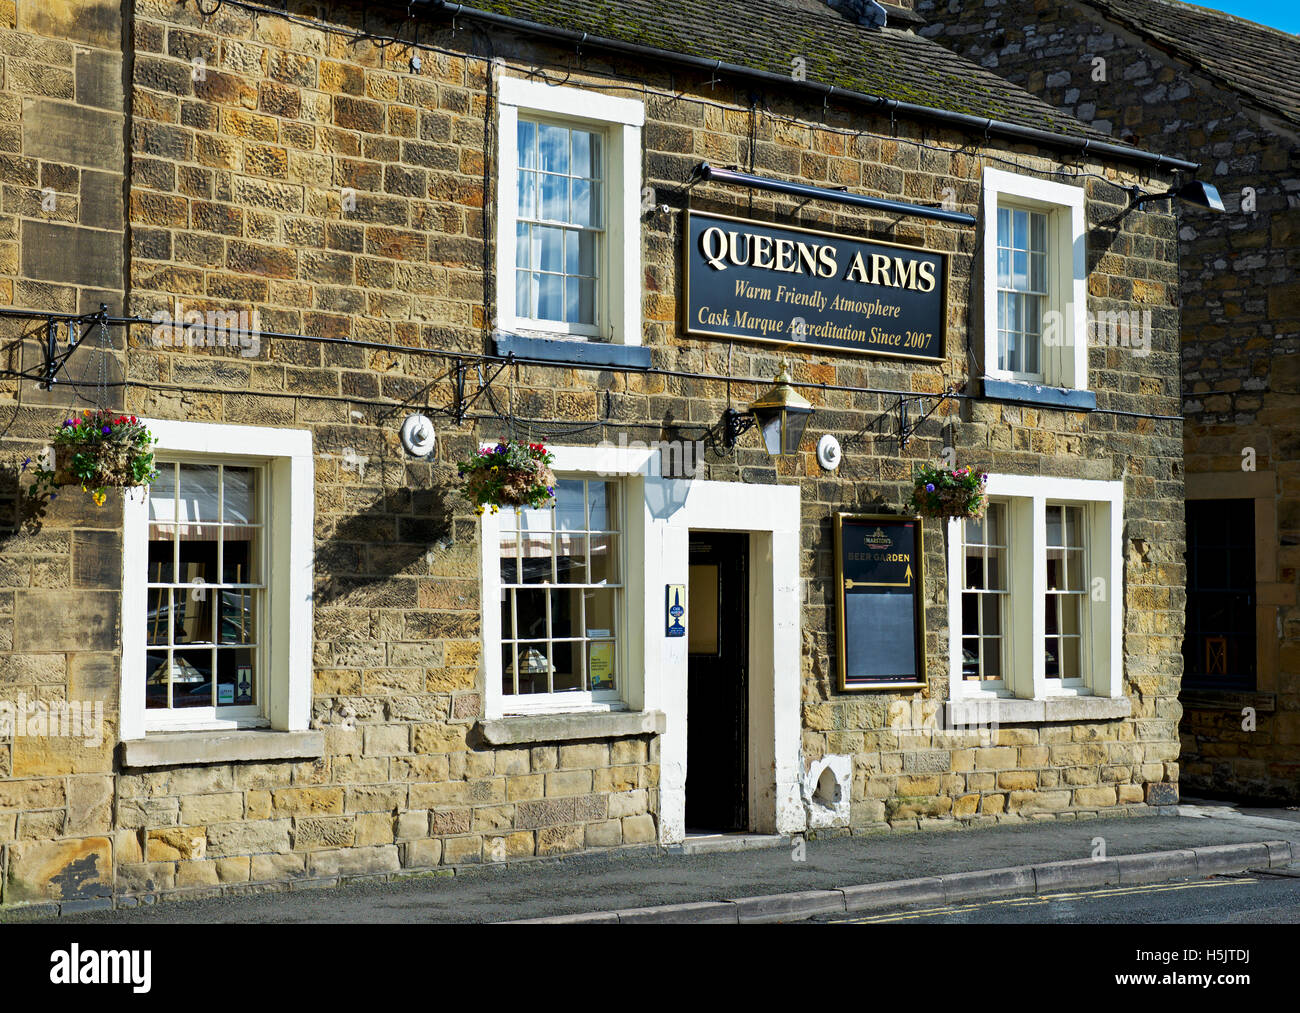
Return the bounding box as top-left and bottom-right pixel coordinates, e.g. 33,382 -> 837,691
497,77 -> 645,345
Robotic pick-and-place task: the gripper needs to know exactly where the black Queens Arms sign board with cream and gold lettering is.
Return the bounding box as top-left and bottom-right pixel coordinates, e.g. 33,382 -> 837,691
684,211 -> 948,360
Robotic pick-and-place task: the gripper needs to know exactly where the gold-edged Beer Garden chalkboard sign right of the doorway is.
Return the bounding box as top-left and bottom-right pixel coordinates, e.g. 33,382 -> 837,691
835,514 -> 926,691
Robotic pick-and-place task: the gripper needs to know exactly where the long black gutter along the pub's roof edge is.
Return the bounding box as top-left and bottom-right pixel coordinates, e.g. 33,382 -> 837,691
411,0 -> 1201,173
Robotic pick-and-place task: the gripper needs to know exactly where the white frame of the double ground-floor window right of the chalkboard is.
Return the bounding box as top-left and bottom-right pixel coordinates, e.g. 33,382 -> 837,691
948,475 -> 1125,701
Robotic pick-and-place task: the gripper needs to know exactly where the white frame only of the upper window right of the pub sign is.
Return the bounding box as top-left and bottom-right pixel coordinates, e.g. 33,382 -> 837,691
983,169 -> 1088,390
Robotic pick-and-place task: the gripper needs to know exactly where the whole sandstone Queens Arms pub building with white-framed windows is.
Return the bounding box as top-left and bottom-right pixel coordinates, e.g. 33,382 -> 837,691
0,0 -> 1196,908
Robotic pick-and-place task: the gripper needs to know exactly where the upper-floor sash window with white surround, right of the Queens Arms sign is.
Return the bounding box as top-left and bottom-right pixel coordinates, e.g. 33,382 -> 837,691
983,169 -> 1088,390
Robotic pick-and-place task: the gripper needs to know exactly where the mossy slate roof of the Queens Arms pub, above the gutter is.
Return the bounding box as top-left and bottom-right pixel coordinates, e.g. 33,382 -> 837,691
467,0 -> 1113,142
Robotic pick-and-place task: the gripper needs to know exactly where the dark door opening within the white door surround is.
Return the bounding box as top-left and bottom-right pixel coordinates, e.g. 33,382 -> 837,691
686,532 -> 749,831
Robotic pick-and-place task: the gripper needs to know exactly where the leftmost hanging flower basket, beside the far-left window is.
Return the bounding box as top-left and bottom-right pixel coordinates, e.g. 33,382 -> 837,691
31,408 -> 157,506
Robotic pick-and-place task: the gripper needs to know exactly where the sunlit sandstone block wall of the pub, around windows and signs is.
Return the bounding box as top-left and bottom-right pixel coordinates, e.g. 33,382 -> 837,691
0,0 -> 1183,902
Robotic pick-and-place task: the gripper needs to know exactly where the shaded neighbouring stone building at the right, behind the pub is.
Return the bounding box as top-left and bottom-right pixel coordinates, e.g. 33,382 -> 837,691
917,0 -> 1300,801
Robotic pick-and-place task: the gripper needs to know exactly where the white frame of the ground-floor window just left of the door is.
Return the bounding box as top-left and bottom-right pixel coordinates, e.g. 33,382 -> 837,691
480,442 -> 653,720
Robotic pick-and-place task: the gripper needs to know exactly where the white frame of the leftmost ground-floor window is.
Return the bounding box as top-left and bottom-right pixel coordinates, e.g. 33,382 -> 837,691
121,419 -> 315,740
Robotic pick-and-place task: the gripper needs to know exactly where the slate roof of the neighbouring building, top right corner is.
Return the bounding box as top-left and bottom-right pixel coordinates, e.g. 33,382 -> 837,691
1080,0 -> 1300,124
